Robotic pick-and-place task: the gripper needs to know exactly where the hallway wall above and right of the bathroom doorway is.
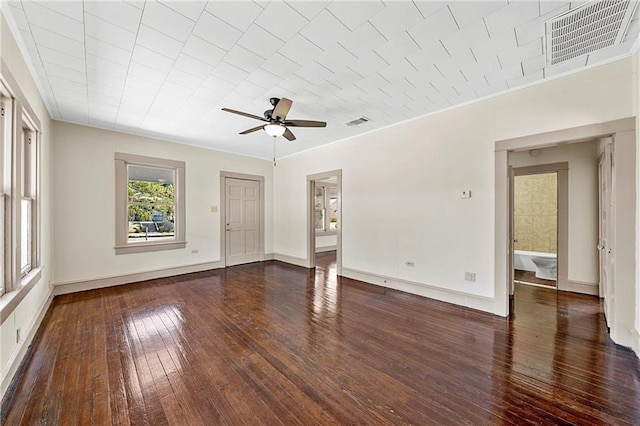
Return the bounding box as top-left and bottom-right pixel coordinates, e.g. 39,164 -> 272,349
509,141 -> 600,285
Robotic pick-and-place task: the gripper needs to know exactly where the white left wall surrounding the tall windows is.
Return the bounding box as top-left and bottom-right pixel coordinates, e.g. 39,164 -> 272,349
0,12 -> 53,396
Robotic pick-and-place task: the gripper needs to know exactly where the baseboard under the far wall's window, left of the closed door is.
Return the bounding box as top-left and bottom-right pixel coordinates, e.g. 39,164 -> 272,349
53,261 -> 224,296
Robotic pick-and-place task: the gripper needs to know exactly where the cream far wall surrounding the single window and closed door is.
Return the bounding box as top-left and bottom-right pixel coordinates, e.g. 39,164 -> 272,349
53,121 -> 273,285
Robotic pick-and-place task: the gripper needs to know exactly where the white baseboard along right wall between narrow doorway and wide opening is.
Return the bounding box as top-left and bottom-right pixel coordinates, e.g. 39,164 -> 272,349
342,266 -> 495,314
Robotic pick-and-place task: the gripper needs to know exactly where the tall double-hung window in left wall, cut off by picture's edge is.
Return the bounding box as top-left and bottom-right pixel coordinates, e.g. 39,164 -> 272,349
0,76 -> 41,303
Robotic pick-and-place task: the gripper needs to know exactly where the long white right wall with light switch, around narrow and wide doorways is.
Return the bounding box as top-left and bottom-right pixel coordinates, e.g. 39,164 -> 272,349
274,58 -> 633,315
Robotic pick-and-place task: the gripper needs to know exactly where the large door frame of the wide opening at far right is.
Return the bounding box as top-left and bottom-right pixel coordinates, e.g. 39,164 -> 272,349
494,117 -> 640,346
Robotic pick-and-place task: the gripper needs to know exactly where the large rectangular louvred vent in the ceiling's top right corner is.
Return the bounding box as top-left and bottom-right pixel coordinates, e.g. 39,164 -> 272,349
545,0 -> 636,65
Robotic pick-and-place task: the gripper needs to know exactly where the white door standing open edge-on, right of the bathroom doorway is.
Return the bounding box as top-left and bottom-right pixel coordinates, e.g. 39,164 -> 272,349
598,143 -> 614,324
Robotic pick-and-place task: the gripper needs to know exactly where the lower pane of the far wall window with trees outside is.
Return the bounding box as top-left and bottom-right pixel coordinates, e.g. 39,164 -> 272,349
128,204 -> 175,243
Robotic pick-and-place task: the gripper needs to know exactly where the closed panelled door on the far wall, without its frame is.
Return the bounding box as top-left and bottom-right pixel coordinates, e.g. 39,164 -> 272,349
225,177 -> 262,266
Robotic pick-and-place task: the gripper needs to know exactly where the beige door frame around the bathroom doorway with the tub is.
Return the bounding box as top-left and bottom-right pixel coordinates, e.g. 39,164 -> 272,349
509,161 -> 570,296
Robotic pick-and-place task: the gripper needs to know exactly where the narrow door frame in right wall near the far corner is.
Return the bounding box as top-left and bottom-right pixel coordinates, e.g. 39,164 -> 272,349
307,169 -> 342,275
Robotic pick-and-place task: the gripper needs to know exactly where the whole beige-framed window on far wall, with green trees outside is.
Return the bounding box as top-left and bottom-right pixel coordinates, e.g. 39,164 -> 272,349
115,153 -> 186,254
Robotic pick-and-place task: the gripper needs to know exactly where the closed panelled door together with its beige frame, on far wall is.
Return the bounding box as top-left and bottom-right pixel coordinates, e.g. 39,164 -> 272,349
220,172 -> 264,267
